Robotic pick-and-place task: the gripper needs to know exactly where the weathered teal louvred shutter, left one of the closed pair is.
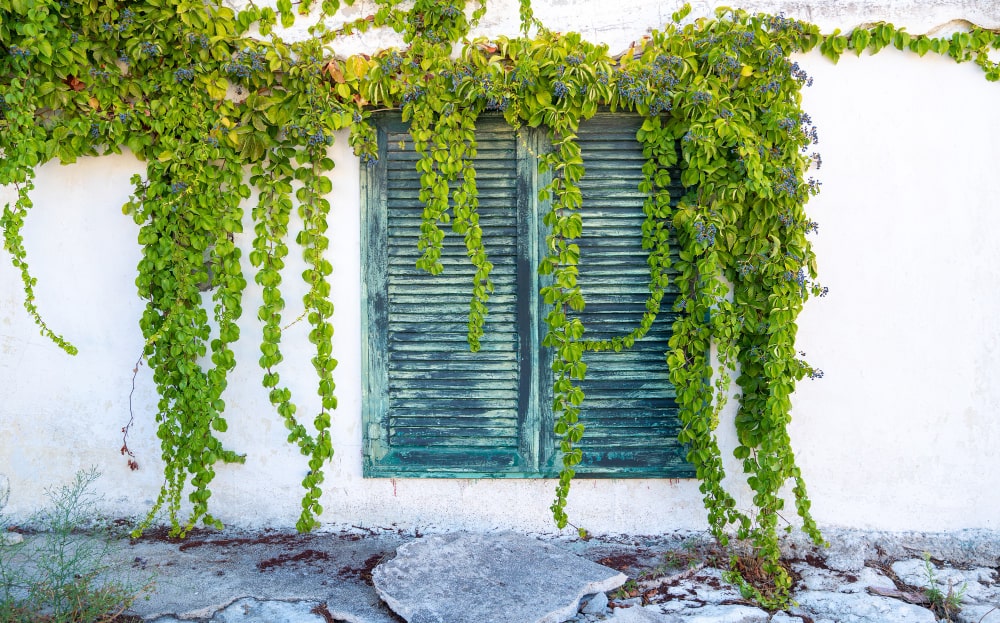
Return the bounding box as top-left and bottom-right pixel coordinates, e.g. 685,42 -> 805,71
362,117 -> 537,477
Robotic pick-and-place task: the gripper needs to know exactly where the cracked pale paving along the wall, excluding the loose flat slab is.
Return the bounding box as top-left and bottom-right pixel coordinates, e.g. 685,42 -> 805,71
0,529 -> 1000,623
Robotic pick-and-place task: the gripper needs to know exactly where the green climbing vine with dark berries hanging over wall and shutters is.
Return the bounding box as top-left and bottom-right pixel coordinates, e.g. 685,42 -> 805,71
0,0 -> 1000,605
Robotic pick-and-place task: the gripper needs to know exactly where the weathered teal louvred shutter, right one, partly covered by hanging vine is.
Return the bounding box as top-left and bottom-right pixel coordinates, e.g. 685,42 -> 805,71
556,114 -> 694,478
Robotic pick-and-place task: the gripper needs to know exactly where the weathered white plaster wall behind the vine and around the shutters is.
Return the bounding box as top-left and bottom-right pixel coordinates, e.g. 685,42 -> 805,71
0,0 -> 1000,533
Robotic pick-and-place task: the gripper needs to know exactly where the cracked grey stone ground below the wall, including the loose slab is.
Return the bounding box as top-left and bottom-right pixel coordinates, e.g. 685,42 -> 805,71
0,529 -> 1000,623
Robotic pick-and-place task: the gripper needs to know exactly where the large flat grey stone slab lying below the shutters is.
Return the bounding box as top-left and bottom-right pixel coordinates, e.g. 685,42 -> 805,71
372,533 -> 626,623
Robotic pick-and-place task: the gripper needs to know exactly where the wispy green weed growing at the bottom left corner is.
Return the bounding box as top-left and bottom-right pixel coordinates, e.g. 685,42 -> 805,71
0,469 -> 152,623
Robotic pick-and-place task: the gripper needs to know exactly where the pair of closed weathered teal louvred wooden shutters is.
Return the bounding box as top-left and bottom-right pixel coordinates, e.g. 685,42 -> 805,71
362,115 -> 693,478
